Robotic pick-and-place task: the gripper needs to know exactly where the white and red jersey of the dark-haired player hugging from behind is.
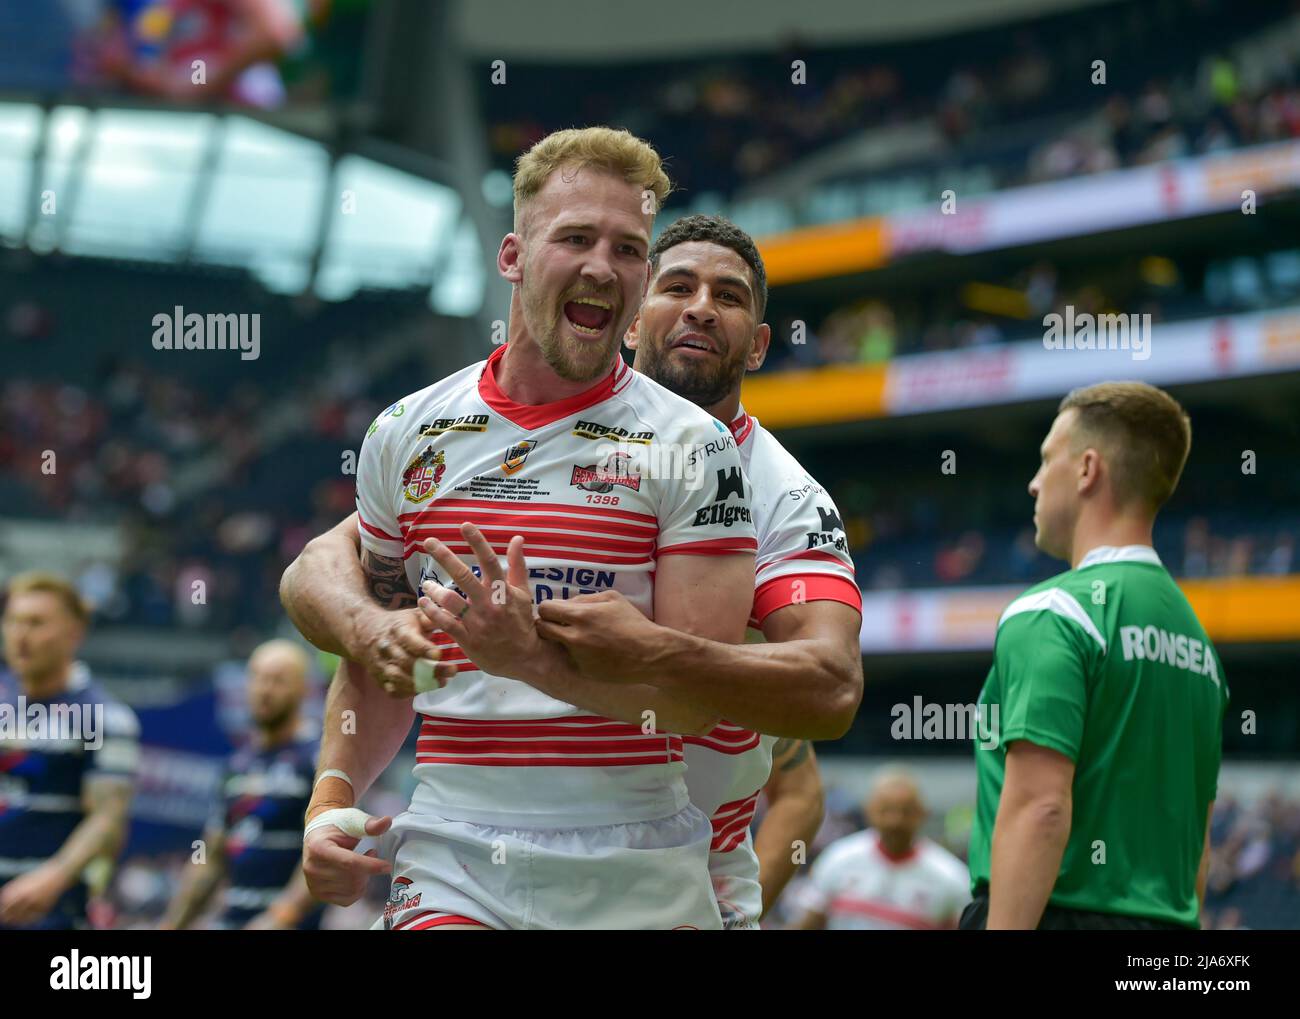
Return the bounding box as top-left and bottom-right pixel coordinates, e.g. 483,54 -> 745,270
685,408 -> 862,919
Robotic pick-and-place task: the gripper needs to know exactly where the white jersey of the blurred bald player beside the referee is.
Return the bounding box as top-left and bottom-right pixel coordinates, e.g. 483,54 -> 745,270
798,828 -> 971,931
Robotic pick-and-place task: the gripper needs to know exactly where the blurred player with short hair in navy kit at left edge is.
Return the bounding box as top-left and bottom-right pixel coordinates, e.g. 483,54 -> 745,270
0,573 -> 139,931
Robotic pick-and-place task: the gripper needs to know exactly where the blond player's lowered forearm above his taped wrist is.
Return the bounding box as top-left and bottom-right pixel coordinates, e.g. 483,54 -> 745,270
307,662 -> 415,819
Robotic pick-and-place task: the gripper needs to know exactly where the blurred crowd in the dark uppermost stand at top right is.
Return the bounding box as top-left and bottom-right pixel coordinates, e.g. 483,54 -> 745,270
482,0 -> 1300,201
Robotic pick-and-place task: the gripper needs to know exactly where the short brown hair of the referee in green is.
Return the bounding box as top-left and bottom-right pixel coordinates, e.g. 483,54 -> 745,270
1057,382 -> 1192,513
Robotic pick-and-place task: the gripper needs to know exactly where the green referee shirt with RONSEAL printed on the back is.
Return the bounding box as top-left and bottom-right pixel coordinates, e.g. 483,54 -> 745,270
970,545 -> 1227,927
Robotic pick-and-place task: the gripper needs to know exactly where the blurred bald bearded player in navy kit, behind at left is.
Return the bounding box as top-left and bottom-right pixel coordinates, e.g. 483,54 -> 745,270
160,641 -> 324,931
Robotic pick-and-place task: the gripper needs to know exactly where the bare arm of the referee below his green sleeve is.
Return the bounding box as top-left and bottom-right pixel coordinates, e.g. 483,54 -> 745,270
987,789 -> 1070,931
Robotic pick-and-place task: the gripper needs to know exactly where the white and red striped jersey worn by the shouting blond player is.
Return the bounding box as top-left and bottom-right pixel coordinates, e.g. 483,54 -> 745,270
356,347 -> 755,828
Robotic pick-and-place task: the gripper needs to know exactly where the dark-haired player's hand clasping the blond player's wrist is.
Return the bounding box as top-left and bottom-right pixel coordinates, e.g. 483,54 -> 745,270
537,591 -> 659,682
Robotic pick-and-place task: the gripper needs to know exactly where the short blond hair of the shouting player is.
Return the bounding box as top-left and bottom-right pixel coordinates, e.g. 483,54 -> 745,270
515,127 -> 672,230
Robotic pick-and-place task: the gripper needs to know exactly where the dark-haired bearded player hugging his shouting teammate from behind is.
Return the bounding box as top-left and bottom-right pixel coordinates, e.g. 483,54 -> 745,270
286,216 -> 862,929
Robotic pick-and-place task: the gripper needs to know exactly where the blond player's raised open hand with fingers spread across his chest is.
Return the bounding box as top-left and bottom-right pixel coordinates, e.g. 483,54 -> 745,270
420,524 -> 546,678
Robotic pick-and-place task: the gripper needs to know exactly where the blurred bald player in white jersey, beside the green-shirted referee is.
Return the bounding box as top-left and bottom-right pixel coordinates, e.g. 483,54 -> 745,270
792,769 -> 970,931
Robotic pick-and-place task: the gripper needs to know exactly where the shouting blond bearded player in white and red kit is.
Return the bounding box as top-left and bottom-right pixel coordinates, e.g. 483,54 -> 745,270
284,127 -> 755,929
